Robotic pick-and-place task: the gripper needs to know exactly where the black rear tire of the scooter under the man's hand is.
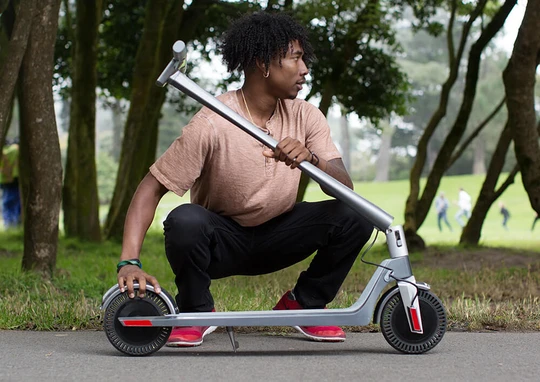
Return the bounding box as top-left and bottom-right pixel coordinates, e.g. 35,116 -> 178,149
103,290 -> 172,356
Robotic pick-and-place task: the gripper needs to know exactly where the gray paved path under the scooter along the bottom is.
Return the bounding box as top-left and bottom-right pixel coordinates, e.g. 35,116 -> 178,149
0,331 -> 540,382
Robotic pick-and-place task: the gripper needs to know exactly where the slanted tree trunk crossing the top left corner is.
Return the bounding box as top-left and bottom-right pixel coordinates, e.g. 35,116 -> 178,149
0,0 -> 35,147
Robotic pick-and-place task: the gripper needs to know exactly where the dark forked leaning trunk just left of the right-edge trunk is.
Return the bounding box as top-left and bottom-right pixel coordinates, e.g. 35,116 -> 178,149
459,123 -> 517,246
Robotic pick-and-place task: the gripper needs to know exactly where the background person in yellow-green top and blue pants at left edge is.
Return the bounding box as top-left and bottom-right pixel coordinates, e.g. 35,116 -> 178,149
0,139 -> 21,229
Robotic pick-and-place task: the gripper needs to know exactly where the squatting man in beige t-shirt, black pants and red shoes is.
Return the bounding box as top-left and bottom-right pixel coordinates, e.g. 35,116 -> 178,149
118,13 -> 373,346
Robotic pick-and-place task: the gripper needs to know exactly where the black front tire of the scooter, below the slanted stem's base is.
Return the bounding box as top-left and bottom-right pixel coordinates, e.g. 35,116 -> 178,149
380,289 -> 447,354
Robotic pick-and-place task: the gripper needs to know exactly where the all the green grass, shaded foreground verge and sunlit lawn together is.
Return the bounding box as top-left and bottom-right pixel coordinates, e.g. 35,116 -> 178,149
0,176 -> 540,330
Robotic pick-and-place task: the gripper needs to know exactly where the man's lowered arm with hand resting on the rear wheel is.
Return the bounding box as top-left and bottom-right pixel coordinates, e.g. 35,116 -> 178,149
118,173 -> 168,298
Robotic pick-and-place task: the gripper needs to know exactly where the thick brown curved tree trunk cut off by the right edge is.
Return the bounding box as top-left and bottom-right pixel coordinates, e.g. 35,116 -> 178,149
503,1 -> 540,213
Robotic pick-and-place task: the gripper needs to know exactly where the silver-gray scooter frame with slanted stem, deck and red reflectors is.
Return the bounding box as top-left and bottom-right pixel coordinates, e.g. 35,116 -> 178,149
102,41 -> 446,352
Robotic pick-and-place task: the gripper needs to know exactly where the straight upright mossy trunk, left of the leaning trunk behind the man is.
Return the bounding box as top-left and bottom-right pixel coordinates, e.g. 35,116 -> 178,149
63,0 -> 102,241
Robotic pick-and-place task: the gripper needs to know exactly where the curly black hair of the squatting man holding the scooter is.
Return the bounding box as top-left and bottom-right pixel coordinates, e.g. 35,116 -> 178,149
221,12 -> 315,72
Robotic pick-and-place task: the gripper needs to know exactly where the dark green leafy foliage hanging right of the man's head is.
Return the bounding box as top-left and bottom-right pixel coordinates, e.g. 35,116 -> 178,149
296,0 -> 414,120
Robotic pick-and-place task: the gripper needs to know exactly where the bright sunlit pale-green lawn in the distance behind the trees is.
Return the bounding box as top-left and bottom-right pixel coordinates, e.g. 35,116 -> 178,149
152,174 -> 540,250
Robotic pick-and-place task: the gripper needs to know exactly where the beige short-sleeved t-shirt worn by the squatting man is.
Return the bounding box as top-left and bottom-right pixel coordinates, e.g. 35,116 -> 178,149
150,91 -> 341,227
